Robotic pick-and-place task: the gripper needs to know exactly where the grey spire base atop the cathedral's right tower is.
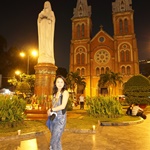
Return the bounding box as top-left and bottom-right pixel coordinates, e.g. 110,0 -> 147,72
112,0 -> 132,13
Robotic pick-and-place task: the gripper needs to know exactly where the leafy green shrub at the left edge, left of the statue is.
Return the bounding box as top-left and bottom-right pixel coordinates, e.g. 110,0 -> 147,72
0,95 -> 26,127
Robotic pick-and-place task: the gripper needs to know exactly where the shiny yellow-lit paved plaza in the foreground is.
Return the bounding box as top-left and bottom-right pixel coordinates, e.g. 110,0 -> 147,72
0,114 -> 150,150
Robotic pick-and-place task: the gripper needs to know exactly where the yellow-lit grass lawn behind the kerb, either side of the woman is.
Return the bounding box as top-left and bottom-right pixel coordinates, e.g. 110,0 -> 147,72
0,109 -> 143,137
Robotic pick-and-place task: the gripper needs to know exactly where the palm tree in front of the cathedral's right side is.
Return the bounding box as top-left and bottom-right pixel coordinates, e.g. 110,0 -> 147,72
98,71 -> 123,95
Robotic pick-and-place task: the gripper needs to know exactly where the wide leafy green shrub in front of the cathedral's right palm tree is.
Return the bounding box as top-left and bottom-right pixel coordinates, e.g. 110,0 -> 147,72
86,96 -> 123,118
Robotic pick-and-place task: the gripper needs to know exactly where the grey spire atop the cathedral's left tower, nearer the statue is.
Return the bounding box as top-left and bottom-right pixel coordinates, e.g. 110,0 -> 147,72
73,0 -> 91,18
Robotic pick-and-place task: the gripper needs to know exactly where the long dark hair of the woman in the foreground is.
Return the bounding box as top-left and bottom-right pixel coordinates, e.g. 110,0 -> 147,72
53,75 -> 67,94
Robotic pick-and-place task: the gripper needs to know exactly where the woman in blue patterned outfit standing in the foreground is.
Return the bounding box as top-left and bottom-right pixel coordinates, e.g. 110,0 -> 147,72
47,75 -> 69,150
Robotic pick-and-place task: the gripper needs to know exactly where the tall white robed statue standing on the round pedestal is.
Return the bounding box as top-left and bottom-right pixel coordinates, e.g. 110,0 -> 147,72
37,1 -> 55,64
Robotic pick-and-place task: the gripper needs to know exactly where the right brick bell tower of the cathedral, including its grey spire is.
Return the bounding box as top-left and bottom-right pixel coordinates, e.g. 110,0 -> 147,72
112,0 -> 139,82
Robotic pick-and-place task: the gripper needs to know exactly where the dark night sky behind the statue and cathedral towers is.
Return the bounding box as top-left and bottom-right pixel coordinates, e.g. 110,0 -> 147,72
0,0 -> 150,70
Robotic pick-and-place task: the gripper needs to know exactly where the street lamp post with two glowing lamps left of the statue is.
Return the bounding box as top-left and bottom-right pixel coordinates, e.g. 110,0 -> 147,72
20,50 -> 38,74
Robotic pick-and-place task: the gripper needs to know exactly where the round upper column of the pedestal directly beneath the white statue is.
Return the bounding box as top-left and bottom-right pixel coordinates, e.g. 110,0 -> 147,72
34,63 -> 57,97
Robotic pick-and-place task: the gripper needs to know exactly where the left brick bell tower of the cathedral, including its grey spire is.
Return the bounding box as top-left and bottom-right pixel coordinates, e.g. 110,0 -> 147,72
70,0 -> 92,94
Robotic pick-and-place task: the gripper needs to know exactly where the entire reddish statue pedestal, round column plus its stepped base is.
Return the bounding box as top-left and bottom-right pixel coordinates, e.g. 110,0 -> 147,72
25,63 -> 57,120
